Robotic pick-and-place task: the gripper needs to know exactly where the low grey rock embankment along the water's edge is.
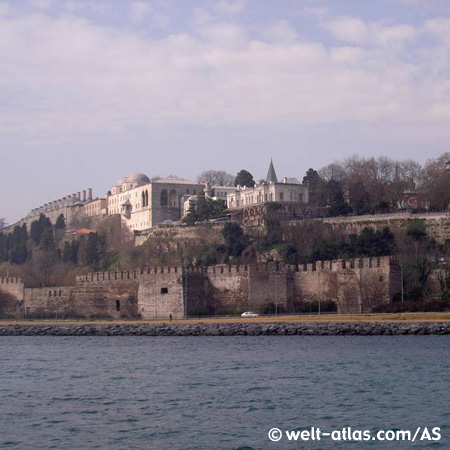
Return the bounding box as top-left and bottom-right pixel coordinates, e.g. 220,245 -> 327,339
0,322 -> 450,336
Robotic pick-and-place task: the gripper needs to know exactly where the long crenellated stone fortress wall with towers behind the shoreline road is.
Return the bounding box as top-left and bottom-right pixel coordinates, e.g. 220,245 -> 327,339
0,257 -> 401,319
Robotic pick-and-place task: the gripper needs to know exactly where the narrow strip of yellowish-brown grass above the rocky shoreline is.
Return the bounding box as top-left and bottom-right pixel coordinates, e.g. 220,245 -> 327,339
0,312 -> 450,325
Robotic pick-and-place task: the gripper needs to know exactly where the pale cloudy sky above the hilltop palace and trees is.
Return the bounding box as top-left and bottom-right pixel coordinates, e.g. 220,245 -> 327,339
0,0 -> 450,223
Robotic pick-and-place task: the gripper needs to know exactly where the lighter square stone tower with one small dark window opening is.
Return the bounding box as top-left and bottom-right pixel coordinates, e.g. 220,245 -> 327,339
137,267 -> 184,319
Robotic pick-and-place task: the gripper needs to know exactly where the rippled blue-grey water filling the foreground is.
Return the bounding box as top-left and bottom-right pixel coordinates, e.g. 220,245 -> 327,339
0,336 -> 450,450
